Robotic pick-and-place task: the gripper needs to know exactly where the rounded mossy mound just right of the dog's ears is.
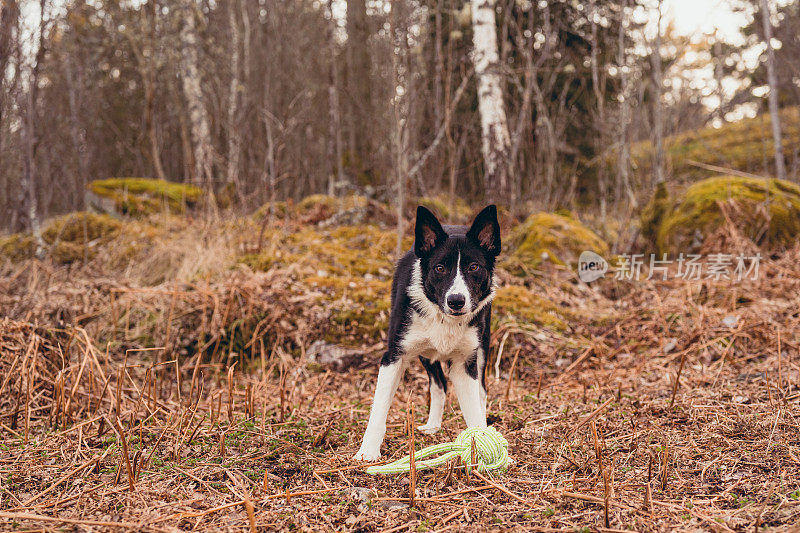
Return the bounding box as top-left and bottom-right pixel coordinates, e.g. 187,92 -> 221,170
502,212 -> 608,275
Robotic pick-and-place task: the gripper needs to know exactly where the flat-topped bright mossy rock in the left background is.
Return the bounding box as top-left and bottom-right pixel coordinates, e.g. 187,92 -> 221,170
89,178 -> 203,217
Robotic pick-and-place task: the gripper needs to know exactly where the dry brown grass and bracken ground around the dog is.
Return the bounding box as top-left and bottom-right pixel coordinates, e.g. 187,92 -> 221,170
0,210 -> 800,531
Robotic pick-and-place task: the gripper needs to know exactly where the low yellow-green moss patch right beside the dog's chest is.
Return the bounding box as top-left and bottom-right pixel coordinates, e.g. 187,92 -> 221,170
492,285 -> 569,331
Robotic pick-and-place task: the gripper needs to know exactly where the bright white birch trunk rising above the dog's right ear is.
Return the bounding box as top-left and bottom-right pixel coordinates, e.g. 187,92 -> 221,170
472,0 -> 511,203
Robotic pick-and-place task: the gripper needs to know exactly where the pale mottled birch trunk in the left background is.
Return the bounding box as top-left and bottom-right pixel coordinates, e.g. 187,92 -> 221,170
180,0 -> 213,189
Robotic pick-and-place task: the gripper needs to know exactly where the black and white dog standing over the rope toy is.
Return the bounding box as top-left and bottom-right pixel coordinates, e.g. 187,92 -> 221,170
354,205 -> 500,461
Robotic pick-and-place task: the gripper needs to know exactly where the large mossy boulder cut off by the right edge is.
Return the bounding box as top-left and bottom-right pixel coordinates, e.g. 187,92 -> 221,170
654,176 -> 800,253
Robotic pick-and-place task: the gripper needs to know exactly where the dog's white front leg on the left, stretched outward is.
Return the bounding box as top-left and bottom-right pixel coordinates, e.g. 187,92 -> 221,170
353,357 -> 406,461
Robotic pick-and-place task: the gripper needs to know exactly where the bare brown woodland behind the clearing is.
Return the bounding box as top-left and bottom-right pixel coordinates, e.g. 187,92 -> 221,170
0,0 -> 800,231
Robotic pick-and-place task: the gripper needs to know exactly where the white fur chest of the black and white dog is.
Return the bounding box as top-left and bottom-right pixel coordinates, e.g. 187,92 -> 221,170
401,311 -> 478,361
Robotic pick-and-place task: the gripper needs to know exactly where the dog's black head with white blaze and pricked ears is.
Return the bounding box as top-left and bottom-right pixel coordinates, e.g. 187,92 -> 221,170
414,205 -> 500,317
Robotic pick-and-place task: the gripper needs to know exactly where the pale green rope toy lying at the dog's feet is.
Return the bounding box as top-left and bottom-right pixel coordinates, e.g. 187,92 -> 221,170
367,426 -> 511,474
